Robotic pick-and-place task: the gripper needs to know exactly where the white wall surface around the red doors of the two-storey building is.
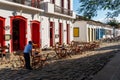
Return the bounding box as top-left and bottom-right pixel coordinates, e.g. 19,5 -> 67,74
0,0 -> 73,52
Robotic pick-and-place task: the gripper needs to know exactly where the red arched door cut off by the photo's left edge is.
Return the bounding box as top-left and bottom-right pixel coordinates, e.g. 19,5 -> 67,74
0,16 -> 5,46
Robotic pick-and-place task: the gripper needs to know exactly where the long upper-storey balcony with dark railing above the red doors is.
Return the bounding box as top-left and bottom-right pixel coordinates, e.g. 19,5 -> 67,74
5,0 -> 73,17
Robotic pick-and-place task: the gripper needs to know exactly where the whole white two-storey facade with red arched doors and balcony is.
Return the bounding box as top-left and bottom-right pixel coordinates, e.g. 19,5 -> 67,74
0,0 -> 75,52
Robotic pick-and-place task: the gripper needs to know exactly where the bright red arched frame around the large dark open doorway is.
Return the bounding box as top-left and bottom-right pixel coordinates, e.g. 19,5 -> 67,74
10,16 -> 27,52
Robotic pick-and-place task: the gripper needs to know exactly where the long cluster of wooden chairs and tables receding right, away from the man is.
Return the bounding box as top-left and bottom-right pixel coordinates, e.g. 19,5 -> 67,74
53,41 -> 100,59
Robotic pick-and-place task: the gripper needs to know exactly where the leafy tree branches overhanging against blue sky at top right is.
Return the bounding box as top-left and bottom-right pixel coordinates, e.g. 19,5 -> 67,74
78,0 -> 120,19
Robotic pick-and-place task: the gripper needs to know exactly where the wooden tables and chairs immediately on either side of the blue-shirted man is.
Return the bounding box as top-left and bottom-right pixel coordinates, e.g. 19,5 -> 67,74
11,44 -> 49,69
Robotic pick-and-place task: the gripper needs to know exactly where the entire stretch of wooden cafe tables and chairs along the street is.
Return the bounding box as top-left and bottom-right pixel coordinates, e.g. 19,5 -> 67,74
0,41 -> 100,69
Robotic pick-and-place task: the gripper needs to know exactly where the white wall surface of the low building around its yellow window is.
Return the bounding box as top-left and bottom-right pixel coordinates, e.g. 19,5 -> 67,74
74,21 -> 115,42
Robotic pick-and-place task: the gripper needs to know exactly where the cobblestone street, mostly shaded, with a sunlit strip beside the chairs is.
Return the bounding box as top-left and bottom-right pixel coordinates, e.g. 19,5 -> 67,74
0,43 -> 120,80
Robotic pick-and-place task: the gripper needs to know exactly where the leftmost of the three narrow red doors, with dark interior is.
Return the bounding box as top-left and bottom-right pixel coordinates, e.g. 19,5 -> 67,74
49,22 -> 55,46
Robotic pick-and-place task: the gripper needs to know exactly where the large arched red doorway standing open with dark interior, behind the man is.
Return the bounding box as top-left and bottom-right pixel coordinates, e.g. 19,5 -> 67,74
10,16 -> 27,52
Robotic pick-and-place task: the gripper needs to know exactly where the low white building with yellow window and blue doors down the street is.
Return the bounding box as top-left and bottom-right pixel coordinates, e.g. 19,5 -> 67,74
73,20 -> 120,42
